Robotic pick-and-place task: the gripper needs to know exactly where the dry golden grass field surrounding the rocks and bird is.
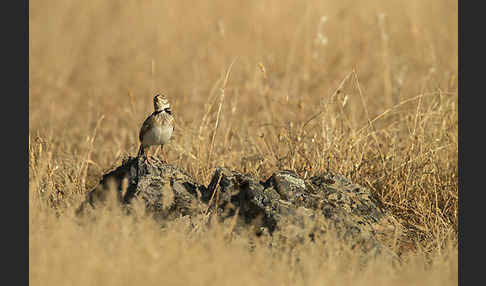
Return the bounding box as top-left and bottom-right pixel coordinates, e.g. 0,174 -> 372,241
29,0 -> 458,285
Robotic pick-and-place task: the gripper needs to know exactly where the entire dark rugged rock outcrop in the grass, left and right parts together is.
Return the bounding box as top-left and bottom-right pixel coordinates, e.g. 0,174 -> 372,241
78,157 -> 394,260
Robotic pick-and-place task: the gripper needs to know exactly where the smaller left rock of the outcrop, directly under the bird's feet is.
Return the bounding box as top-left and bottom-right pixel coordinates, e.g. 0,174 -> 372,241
77,157 -> 206,219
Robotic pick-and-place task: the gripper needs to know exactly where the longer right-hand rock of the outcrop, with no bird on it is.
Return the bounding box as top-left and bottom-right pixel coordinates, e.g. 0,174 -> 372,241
203,168 -> 394,260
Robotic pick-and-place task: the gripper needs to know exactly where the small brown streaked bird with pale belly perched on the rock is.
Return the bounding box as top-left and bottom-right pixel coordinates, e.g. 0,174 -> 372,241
138,93 -> 174,164
